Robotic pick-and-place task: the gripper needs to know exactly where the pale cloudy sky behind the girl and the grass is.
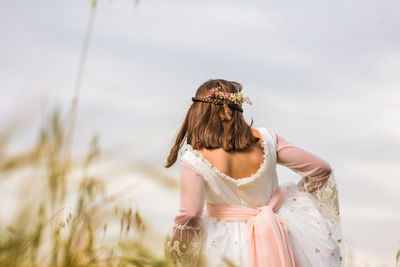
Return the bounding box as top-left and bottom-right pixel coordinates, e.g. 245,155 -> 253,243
0,0 -> 400,266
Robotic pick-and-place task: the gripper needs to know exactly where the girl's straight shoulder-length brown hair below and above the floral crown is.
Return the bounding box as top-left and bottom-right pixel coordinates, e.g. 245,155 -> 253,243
165,79 -> 259,168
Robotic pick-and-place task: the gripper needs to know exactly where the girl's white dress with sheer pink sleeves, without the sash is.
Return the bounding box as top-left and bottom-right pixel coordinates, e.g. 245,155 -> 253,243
165,127 -> 344,267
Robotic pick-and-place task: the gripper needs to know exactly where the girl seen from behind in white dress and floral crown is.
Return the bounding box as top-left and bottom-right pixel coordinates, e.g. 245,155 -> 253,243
165,79 -> 344,267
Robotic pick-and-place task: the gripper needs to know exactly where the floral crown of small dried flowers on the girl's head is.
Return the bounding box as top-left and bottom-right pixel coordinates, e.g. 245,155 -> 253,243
192,86 -> 252,112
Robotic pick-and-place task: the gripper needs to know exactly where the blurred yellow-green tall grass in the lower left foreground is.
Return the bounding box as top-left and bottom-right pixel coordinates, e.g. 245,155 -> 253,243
0,111 -> 170,267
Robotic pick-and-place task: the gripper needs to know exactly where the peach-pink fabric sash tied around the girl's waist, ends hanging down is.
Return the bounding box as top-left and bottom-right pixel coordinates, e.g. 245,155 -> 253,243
207,186 -> 300,267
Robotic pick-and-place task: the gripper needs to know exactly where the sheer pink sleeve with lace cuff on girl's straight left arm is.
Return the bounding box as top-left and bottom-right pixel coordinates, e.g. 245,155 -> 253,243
164,161 -> 204,266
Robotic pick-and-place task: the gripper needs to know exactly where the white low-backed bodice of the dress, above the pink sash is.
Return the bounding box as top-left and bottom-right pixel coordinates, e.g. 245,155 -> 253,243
182,127 -> 279,208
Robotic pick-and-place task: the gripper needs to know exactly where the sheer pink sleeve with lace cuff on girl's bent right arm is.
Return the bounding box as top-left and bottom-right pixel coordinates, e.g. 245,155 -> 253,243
276,134 -> 345,263
